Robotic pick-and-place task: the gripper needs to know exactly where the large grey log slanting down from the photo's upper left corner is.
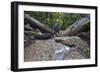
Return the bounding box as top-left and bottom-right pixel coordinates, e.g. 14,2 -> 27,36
24,15 -> 55,34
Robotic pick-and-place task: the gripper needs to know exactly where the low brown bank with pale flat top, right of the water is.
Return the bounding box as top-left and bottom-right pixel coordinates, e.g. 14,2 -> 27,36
55,36 -> 90,58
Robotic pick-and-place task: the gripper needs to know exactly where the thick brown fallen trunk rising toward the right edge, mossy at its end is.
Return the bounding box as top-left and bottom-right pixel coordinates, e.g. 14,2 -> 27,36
58,18 -> 90,36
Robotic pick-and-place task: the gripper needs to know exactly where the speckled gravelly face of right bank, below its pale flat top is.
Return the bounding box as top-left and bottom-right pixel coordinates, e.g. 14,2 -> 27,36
62,39 -> 90,58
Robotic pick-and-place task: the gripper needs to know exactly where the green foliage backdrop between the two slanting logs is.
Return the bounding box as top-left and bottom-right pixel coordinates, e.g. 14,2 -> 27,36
25,11 -> 80,29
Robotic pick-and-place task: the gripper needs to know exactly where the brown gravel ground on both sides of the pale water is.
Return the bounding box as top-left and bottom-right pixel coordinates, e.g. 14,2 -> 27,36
24,39 -> 86,62
